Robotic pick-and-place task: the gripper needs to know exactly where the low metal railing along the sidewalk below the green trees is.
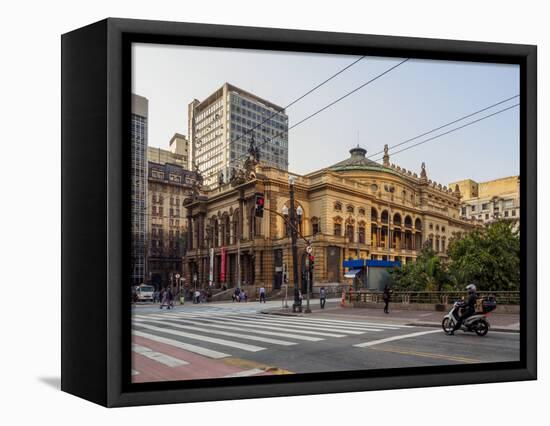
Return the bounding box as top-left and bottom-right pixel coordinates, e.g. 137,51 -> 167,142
346,289 -> 520,305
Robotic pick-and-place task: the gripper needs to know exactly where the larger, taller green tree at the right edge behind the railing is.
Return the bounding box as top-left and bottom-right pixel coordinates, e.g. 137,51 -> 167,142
448,220 -> 520,291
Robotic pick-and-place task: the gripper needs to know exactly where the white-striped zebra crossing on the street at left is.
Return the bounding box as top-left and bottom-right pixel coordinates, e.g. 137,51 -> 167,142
132,307 -> 413,377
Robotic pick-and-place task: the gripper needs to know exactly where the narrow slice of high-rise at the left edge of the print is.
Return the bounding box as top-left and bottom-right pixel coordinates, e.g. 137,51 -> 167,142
130,94 -> 149,285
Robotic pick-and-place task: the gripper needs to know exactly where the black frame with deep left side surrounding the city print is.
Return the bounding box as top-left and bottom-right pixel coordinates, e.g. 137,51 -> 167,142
61,18 -> 537,407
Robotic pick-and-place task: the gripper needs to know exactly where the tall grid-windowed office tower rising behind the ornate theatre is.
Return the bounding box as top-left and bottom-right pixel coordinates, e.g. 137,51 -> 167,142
188,83 -> 288,187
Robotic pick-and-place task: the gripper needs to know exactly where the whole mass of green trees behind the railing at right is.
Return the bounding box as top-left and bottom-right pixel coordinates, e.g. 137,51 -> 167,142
389,221 -> 520,291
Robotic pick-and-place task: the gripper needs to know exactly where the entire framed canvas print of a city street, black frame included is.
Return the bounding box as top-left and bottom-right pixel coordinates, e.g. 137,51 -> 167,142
62,19 -> 537,406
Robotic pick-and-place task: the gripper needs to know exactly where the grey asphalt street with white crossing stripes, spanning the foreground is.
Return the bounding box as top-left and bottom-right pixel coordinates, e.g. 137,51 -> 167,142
132,302 -> 519,381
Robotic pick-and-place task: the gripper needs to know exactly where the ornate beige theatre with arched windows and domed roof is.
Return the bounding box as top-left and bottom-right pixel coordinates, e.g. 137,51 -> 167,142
184,147 -> 475,289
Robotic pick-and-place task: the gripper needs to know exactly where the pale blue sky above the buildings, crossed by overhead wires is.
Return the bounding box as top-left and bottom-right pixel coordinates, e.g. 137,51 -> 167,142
132,44 -> 519,185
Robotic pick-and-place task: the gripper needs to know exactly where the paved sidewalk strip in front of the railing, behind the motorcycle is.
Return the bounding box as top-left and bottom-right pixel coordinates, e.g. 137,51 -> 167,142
263,300 -> 519,332
